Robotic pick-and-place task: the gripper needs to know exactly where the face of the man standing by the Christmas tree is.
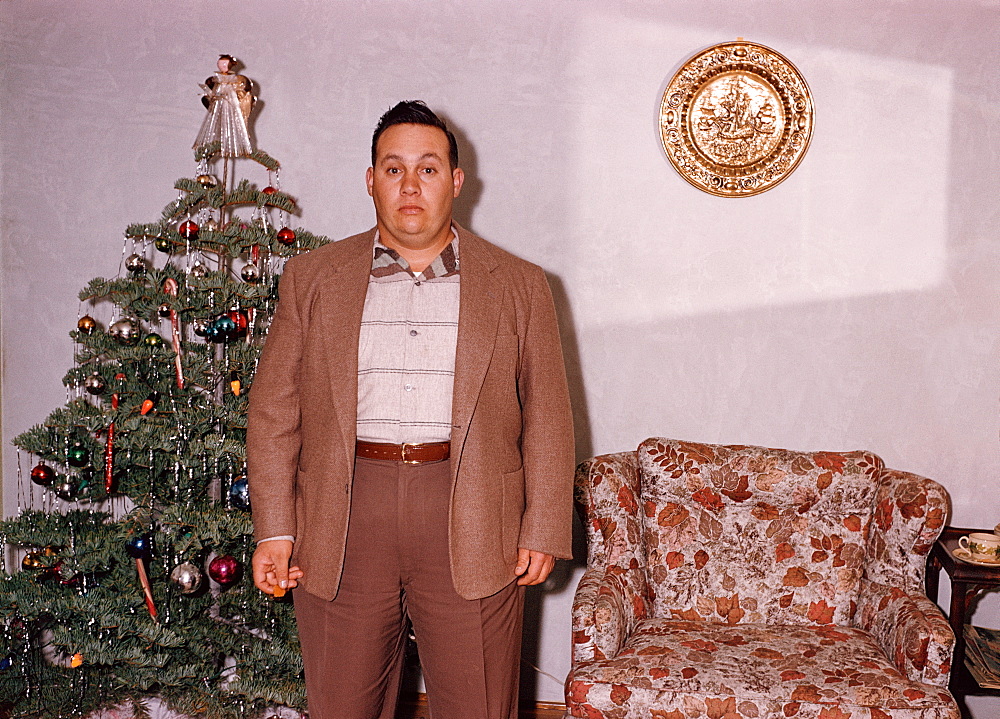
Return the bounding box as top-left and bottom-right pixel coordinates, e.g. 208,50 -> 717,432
367,124 -> 464,249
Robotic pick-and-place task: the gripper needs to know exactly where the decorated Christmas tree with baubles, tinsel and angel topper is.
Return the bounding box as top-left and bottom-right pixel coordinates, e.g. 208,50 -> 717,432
0,56 -> 326,717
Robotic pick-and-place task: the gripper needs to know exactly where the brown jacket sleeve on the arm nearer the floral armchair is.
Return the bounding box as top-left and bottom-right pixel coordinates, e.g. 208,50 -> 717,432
518,267 -> 575,559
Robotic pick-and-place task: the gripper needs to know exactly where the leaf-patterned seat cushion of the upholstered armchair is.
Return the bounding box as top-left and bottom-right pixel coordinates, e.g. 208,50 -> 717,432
567,619 -> 954,719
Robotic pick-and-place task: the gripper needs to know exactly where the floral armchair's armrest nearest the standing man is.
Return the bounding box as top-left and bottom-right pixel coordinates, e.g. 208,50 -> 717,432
573,561 -> 649,664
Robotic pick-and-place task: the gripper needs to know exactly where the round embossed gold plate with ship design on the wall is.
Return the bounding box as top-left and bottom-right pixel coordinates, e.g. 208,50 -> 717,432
660,40 -> 813,197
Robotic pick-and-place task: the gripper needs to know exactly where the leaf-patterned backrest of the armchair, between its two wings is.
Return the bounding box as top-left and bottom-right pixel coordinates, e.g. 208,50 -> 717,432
637,438 -> 884,624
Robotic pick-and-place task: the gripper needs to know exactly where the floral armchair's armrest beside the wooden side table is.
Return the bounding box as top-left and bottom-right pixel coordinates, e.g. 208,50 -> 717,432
854,580 -> 955,687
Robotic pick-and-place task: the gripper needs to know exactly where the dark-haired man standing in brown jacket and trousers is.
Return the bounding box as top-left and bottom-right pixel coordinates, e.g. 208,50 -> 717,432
247,102 -> 573,719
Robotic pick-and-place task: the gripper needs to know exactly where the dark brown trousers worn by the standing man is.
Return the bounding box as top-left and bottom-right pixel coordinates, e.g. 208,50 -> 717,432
295,458 -> 524,719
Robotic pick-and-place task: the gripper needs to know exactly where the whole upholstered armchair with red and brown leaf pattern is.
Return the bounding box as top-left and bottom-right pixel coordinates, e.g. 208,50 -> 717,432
566,438 -> 959,719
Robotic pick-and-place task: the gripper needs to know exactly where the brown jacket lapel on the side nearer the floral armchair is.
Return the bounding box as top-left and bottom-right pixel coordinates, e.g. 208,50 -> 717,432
451,224 -> 503,478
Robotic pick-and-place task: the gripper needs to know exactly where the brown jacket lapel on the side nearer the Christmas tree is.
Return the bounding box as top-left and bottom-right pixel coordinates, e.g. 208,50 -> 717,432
313,229 -> 375,470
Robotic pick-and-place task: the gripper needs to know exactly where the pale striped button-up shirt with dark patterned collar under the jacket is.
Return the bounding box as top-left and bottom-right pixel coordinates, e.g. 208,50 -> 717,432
357,230 -> 459,444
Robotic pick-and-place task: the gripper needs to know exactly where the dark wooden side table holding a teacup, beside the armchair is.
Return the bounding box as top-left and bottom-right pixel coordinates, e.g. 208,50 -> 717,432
924,527 -> 1000,699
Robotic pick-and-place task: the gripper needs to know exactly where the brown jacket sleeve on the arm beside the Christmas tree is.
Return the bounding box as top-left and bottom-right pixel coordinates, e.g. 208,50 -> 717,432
247,261 -> 304,540
